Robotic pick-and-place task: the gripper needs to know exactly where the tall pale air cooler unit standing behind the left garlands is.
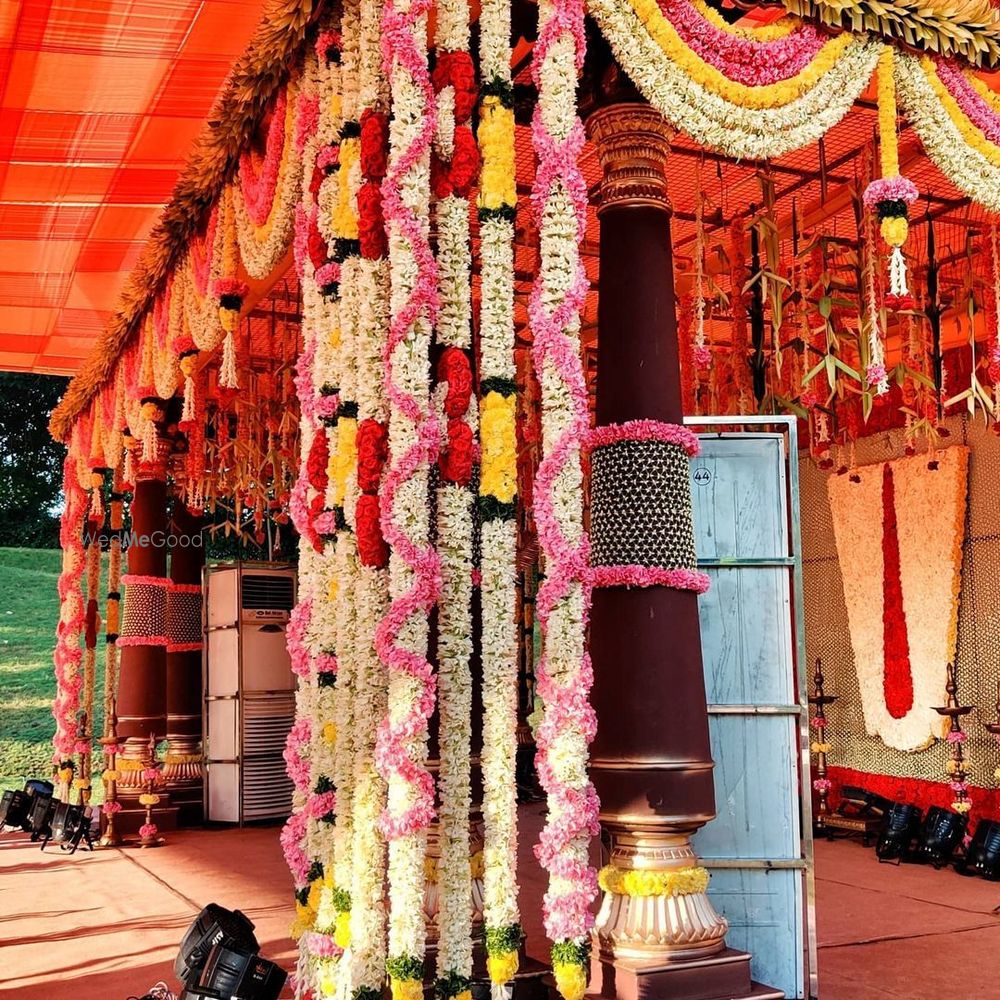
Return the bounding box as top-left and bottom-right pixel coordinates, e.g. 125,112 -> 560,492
204,563 -> 295,824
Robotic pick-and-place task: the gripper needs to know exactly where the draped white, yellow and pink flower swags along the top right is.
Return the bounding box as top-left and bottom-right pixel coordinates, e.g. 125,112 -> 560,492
588,0 -> 1000,211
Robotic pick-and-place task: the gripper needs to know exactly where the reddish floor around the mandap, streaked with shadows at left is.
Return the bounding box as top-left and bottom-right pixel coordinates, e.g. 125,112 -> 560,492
0,806 -> 1000,1000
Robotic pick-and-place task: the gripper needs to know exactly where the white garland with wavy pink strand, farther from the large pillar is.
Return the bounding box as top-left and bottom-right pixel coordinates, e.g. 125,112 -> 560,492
376,0 -> 440,1000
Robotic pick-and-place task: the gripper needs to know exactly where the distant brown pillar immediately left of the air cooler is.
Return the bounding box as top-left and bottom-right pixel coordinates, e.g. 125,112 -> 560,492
163,500 -> 205,825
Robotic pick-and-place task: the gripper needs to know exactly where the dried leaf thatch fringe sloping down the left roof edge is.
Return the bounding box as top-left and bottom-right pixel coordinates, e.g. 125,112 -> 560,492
49,0 -> 323,442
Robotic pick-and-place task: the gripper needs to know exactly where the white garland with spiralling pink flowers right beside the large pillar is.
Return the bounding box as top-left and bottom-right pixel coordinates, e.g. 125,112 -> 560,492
529,0 -> 599,1000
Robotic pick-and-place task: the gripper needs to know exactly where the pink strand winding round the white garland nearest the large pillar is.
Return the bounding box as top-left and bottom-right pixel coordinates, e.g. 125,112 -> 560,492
529,0 -> 599,941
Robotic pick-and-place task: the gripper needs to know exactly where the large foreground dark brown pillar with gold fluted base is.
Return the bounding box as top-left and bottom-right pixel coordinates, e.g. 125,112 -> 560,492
588,103 -> 750,998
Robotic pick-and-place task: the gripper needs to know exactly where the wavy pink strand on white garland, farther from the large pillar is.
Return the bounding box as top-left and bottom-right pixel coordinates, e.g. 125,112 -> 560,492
375,0 -> 441,840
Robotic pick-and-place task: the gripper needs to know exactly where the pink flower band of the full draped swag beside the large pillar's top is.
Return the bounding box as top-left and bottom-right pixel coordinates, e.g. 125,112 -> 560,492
659,0 -> 830,87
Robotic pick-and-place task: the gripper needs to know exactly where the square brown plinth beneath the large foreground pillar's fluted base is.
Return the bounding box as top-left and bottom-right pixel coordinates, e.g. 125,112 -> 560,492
588,948 -> 785,1000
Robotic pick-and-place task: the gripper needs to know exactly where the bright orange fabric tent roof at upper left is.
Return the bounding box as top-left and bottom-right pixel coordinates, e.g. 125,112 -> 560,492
0,0 -> 263,374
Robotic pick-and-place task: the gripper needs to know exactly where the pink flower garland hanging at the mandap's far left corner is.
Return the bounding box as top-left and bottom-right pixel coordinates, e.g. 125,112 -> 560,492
52,454 -> 88,764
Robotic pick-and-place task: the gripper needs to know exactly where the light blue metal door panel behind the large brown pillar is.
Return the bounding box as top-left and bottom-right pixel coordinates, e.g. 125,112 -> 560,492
691,432 -> 811,997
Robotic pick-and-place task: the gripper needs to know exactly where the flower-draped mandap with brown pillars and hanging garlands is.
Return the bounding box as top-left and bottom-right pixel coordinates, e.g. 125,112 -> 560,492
51,0 -> 1000,1000
